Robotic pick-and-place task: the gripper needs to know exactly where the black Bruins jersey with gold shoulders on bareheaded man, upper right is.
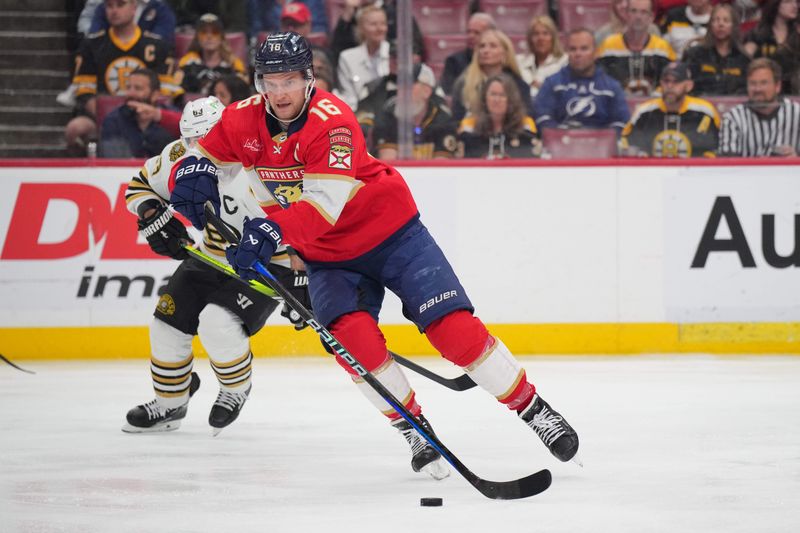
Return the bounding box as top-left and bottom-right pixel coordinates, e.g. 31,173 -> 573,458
597,33 -> 675,96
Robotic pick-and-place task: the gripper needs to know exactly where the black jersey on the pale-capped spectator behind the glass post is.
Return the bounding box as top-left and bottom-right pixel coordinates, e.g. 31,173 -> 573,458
375,95 -> 458,159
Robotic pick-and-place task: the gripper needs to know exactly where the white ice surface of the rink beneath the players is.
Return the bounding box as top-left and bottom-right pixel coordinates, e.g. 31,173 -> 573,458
0,355 -> 800,533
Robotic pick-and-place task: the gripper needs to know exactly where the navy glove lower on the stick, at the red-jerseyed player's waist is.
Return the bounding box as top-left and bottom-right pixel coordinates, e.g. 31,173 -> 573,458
225,218 -> 282,280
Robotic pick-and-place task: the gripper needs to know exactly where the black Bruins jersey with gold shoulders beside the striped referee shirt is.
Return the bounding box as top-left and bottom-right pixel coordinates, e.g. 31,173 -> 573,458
622,96 -> 720,158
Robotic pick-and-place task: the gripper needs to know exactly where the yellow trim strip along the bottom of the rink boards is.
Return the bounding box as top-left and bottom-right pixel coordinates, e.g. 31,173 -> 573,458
0,322 -> 800,361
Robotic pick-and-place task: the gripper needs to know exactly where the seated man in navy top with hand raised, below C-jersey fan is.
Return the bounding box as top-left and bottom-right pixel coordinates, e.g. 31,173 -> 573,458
99,68 -> 180,158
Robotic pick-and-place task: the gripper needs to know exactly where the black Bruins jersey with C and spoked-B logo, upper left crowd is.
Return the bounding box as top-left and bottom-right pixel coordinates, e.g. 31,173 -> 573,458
72,27 -> 181,98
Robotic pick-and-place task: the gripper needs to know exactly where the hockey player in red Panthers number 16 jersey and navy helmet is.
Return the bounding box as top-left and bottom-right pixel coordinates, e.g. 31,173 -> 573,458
170,32 -> 578,479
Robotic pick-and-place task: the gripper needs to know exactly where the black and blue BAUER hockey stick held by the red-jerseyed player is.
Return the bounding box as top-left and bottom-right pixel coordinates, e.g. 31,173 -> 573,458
205,204 -> 552,500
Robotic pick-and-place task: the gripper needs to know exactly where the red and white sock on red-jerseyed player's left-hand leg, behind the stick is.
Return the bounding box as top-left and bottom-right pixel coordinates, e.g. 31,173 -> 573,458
331,311 -> 421,419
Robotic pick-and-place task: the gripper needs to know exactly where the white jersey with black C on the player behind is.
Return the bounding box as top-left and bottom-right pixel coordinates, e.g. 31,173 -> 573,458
125,139 -> 290,267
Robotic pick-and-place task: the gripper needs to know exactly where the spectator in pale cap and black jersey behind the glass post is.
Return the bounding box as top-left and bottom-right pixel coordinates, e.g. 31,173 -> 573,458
374,63 -> 457,160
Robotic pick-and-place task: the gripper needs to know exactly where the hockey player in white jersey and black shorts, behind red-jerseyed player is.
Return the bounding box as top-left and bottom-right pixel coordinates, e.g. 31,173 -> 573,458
122,96 -> 310,435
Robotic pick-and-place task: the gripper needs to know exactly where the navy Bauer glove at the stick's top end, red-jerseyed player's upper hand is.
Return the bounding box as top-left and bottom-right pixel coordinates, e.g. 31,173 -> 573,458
169,156 -> 219,229
